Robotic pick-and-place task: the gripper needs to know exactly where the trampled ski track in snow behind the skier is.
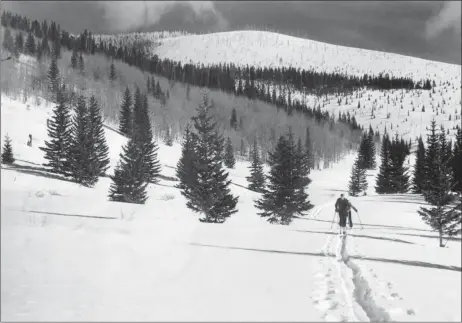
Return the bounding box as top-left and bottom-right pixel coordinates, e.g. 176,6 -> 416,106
313,229 -> 415,322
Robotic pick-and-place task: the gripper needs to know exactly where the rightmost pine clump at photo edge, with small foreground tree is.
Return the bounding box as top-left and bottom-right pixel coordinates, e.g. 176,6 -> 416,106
413,120 -> 462,247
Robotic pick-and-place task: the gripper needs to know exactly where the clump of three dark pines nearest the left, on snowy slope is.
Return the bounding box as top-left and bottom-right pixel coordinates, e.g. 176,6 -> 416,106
40,87 -> 109,187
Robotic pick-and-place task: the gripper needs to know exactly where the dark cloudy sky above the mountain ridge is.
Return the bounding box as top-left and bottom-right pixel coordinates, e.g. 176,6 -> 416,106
2,1 -> 461,64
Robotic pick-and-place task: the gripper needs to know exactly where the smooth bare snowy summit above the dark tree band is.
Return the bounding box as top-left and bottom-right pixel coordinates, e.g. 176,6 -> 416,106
153,30 -> 460,80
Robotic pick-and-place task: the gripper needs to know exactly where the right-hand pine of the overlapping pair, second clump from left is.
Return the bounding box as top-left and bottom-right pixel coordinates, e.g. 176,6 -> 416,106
132,87 -> 160,183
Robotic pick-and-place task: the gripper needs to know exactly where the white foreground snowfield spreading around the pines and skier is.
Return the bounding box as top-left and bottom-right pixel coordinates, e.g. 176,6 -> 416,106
1,96 -> 461,322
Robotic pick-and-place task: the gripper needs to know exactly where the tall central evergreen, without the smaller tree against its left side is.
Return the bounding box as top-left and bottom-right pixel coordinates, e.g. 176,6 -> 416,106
183,96 -> 238,223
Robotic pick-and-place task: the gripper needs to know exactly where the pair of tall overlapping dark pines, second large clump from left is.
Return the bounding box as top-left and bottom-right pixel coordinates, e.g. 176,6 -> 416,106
109,87 -> 161,204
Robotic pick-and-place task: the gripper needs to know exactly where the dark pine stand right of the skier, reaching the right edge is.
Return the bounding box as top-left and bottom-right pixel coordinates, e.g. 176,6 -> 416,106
375,120 -> 462,247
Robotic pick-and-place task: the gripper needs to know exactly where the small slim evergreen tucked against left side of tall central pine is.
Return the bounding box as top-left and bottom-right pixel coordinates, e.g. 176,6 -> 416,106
176,124 -> 197,197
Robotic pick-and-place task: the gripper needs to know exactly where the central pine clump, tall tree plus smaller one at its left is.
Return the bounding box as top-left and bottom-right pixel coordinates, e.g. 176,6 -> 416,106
176,95 -> 238,223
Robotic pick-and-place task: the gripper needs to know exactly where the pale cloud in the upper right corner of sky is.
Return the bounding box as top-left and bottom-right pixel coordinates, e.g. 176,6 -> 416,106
425,0 -> 462,39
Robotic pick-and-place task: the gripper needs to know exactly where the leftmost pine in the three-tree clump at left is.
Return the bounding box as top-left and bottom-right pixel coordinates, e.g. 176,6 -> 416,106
40,90 -> 71,175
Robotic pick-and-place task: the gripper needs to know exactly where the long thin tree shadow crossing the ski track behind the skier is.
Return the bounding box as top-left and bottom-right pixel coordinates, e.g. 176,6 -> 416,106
189,242 -> 462,272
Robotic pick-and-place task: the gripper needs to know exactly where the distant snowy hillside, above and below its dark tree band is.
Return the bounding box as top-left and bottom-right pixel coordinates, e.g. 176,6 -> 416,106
130,31 -> 461,140
